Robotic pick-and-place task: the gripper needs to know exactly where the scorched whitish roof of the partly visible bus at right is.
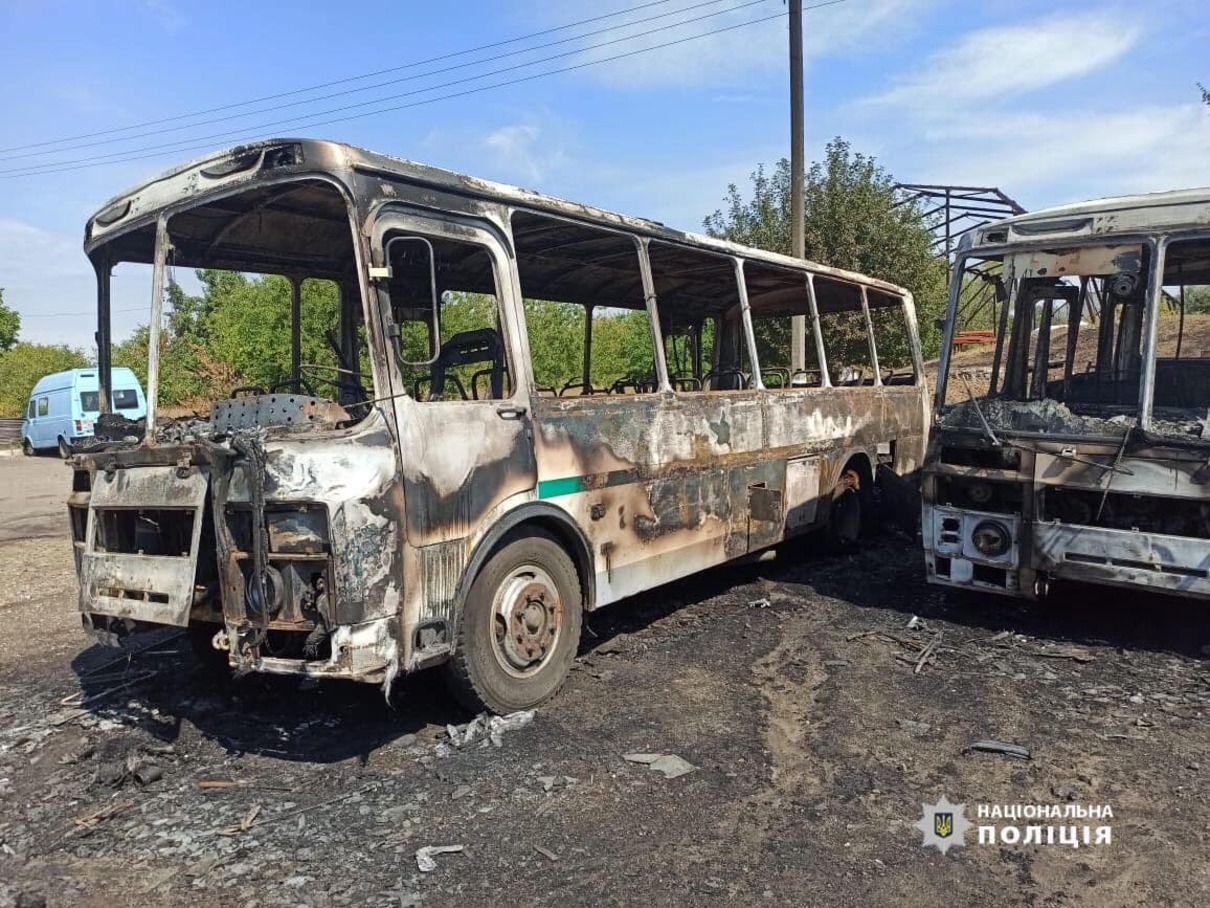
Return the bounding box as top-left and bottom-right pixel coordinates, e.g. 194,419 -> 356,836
958,188 -> 1210,251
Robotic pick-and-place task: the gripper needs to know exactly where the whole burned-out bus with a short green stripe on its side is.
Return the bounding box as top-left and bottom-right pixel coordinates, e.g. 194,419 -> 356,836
70,139 -> 928,712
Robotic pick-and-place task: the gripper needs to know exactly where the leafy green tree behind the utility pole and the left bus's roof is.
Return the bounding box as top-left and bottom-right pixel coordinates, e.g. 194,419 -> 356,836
704,137 -> 947,357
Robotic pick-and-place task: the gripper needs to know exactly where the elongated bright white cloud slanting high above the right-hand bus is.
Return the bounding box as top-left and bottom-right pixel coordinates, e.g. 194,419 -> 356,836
868,11 -> 1142,115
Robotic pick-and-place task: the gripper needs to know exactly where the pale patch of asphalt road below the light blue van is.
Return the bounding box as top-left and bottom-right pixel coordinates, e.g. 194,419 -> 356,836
0,454 -> 71,542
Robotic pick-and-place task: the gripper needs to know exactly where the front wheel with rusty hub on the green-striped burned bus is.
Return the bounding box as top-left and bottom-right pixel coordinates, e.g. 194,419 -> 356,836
445,530 -> 583,714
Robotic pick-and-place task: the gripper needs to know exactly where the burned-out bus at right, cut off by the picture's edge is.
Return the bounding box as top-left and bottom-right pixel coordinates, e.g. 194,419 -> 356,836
922,189 -> 1210,598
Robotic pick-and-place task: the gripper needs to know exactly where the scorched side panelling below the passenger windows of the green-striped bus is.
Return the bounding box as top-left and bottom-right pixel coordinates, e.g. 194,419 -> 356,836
535,387 -> 927,603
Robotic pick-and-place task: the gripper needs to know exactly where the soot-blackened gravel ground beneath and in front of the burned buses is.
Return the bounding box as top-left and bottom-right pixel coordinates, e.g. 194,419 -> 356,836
0,462 -> 1210,908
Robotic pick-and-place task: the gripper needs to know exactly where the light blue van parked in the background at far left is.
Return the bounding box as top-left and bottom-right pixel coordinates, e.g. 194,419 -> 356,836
21,367 -> 148,458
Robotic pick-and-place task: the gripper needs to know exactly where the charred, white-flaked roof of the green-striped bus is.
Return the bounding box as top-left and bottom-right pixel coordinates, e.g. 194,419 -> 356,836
85,138 -> 906,295
